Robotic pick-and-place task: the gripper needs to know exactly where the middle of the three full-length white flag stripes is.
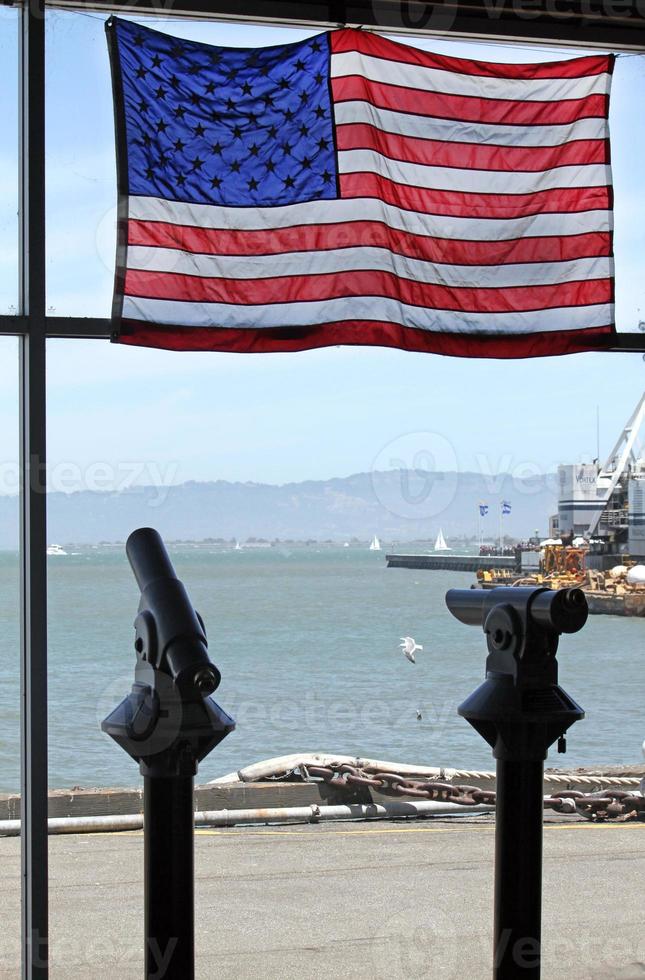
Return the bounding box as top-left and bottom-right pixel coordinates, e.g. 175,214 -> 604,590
128,245 -> 613,289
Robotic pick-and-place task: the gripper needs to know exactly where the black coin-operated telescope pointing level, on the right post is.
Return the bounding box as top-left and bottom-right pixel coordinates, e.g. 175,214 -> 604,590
446,587 -> 588,980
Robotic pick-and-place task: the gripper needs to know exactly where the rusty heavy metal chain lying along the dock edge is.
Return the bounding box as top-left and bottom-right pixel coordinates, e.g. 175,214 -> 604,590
302,763 -> 645,822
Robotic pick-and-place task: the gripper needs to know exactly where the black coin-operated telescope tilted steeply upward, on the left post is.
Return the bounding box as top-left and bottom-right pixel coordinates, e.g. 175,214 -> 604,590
101,528 -> 235,980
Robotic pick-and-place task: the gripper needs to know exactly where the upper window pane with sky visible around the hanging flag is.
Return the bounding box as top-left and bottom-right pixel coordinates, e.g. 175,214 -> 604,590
47,10 -> 645,331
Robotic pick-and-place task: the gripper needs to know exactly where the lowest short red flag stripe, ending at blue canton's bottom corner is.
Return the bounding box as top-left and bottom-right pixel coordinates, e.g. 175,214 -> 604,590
340,173 -> 610,218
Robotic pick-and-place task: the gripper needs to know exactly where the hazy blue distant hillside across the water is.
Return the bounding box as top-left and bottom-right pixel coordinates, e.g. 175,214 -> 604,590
0,470 -> 556,548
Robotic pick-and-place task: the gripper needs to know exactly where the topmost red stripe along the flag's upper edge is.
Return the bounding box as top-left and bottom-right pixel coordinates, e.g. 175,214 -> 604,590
330,28 -> 614,80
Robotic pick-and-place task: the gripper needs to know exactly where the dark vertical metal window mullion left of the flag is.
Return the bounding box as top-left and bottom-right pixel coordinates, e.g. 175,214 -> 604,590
19,0 -> 49,980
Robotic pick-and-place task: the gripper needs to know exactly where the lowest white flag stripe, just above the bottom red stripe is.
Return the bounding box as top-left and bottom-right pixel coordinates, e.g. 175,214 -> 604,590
123,296 -> 613,339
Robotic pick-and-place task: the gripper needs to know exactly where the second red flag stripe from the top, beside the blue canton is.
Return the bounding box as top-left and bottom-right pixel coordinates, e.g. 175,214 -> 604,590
332,75 -> 608,126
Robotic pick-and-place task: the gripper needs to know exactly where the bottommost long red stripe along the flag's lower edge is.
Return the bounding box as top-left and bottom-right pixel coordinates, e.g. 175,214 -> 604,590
119,320 -> 613,359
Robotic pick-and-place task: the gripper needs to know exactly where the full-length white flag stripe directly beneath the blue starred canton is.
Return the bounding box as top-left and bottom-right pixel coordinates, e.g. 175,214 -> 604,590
129,197 -> 613,241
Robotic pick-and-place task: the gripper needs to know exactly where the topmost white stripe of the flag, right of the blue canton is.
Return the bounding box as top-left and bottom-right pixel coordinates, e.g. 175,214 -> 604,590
331,51 -> 611,102
